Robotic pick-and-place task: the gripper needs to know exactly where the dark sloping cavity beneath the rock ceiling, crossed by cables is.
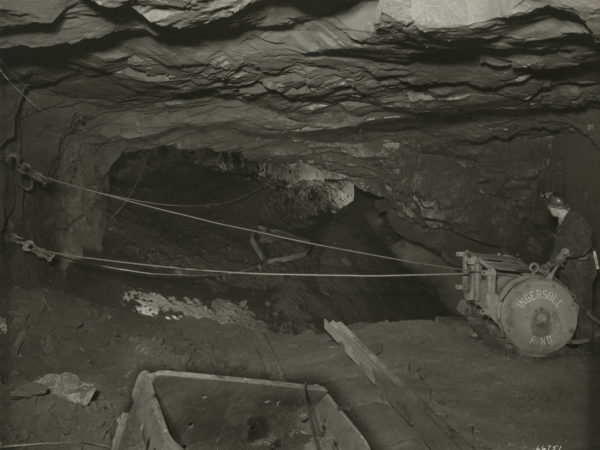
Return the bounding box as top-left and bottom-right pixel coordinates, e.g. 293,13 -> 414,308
59,148 -> 449,333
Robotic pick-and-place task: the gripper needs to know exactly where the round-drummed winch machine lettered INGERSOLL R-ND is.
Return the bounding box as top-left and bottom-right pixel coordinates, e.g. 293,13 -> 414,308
457,250 -> 579,357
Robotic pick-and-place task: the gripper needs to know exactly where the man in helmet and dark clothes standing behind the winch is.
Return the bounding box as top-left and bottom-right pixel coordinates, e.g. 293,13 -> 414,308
542,192 -> 596,349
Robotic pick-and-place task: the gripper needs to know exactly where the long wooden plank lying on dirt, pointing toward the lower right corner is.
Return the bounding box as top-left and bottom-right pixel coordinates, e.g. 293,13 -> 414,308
325,320 -> 473,450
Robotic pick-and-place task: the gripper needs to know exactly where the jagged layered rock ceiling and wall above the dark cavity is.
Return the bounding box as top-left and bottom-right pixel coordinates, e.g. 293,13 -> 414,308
0,0 -> 600,258
